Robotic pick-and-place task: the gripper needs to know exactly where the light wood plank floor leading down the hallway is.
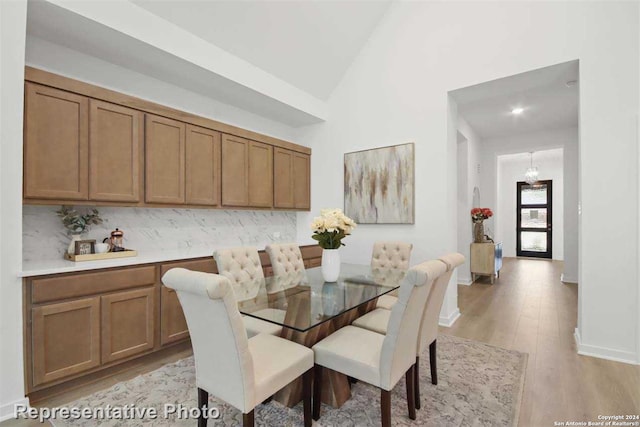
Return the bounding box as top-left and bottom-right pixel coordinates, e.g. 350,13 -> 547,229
2,258 -> 640,427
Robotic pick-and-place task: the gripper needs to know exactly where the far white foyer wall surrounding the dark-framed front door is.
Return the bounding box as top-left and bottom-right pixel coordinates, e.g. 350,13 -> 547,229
495,148 -> 564,260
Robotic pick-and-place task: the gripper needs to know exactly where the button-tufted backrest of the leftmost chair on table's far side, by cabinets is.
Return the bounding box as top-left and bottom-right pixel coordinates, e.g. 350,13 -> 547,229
213,247 -> 264,301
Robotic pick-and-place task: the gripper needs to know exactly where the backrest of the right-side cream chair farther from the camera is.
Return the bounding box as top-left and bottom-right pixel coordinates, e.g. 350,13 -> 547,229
417,252 -> 464,354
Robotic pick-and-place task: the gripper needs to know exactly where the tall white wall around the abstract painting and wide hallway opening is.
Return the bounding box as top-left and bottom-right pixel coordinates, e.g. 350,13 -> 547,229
298,2 -> 639,362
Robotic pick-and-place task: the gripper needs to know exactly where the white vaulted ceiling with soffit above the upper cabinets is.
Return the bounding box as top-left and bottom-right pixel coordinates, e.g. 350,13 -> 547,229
26,0 -> 390,127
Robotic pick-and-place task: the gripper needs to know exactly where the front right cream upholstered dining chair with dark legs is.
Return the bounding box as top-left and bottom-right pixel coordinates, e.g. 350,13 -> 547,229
313,260 -> 446,427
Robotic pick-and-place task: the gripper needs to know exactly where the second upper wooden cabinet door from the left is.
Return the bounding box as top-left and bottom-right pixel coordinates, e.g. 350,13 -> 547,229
89,99 -> 143,202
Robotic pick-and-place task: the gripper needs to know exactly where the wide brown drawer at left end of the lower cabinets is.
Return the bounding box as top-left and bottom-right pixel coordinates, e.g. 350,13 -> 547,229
31,265 -> 156,304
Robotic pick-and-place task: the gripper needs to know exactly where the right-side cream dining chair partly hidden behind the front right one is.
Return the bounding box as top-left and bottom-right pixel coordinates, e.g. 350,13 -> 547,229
352,252 -> 464,409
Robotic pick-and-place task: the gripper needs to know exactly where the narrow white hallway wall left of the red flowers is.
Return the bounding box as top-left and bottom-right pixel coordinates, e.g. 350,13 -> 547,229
457,115 -> 484,285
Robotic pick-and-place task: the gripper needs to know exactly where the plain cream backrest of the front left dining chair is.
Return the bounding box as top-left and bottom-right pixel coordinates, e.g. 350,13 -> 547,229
162,268 -> 255,413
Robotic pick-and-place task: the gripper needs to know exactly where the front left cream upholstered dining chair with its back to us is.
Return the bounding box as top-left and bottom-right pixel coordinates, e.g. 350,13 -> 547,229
162,268 -> 313,427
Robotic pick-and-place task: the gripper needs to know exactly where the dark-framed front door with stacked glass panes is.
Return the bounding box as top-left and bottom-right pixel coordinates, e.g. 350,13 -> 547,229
516,180 -> 552,258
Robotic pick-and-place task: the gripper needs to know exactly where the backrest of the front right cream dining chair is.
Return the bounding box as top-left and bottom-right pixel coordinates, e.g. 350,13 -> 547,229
380,260 -> 446,390
